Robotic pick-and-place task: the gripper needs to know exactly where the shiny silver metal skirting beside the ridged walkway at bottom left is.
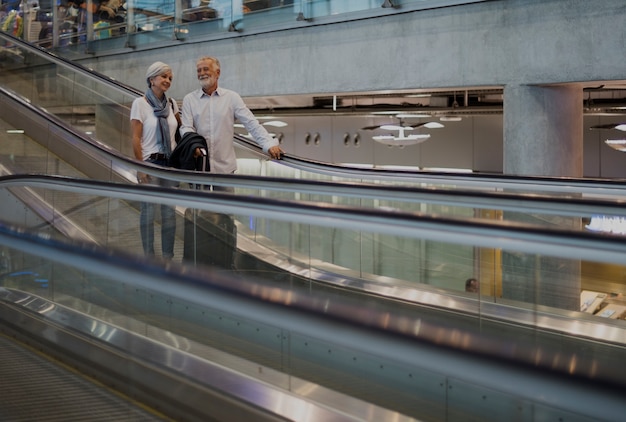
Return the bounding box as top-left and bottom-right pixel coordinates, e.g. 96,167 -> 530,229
0,288 -> 414,422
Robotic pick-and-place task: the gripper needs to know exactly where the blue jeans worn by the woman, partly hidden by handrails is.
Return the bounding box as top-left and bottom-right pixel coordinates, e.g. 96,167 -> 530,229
139,160 -> 176,259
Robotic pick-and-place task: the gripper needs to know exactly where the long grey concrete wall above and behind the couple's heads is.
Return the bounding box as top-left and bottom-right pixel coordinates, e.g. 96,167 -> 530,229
84,0 -> 626,97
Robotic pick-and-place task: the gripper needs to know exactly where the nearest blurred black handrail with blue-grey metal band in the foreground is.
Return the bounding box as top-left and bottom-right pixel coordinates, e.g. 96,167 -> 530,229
0,216 -> 626,416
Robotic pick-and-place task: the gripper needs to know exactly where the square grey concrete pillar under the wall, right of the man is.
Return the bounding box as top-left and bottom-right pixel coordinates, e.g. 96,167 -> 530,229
502,84 -> 583,310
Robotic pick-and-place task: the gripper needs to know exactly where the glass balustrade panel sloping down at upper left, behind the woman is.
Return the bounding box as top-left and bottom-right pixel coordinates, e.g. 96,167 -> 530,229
0,36 -> 139,161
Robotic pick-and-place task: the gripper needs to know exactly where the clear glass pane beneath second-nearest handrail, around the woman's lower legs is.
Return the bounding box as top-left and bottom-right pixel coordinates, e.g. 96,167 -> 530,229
2,181 -> 626,326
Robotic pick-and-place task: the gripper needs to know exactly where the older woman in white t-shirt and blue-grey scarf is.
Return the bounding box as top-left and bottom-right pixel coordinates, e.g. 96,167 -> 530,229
130,62 -> 180,260
